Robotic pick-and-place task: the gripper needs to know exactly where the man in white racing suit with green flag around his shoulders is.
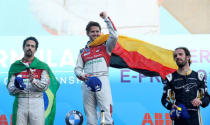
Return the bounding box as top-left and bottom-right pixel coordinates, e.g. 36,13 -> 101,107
7,37 -> 49,125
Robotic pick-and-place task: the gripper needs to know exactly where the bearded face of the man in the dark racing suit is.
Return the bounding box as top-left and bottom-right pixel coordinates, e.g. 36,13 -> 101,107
174,49 -> 190,68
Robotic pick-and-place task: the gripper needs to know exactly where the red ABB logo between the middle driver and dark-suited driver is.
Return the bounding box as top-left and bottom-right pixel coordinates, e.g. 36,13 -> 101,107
142,113 -> 172,125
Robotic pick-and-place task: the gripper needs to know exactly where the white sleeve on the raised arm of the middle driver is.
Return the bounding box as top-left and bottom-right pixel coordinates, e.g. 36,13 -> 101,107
104,17 -> 118,55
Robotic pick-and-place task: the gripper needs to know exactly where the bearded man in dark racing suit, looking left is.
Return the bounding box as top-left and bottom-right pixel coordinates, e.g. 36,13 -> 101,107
161,47 -> 209,125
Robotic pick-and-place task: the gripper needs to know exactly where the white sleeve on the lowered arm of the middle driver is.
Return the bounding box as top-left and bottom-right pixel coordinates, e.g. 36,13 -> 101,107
74,53 -> 84,79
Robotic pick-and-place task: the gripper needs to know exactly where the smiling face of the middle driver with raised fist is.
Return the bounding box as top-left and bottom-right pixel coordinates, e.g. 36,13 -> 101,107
87,26 -> 101,41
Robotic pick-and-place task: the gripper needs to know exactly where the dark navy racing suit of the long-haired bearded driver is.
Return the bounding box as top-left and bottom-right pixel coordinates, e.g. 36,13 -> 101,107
161,70 -> 209,125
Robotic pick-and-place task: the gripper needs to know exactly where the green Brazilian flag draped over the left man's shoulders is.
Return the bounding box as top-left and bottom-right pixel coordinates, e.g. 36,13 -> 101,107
7,57 -> 60,125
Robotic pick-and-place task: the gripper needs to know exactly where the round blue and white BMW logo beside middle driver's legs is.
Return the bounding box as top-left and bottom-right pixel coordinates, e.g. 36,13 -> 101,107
65,110 -> 83,125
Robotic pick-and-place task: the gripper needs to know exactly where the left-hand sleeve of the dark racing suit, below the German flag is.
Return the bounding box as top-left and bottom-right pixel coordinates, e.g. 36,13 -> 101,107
161,77 -> 173,110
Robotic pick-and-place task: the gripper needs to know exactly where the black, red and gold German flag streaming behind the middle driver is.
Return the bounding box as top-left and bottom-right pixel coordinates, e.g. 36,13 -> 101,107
90,35 -> 177,79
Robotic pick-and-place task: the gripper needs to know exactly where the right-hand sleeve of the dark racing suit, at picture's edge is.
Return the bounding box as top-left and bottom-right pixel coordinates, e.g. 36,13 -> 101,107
198,72 -> 210,107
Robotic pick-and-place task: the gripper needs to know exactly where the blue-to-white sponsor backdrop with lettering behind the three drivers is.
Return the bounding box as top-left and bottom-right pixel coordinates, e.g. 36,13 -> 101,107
0,35 -> 210,125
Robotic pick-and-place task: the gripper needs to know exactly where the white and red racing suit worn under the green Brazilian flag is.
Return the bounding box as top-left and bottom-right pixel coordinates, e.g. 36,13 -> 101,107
8,61 -> 49,125
